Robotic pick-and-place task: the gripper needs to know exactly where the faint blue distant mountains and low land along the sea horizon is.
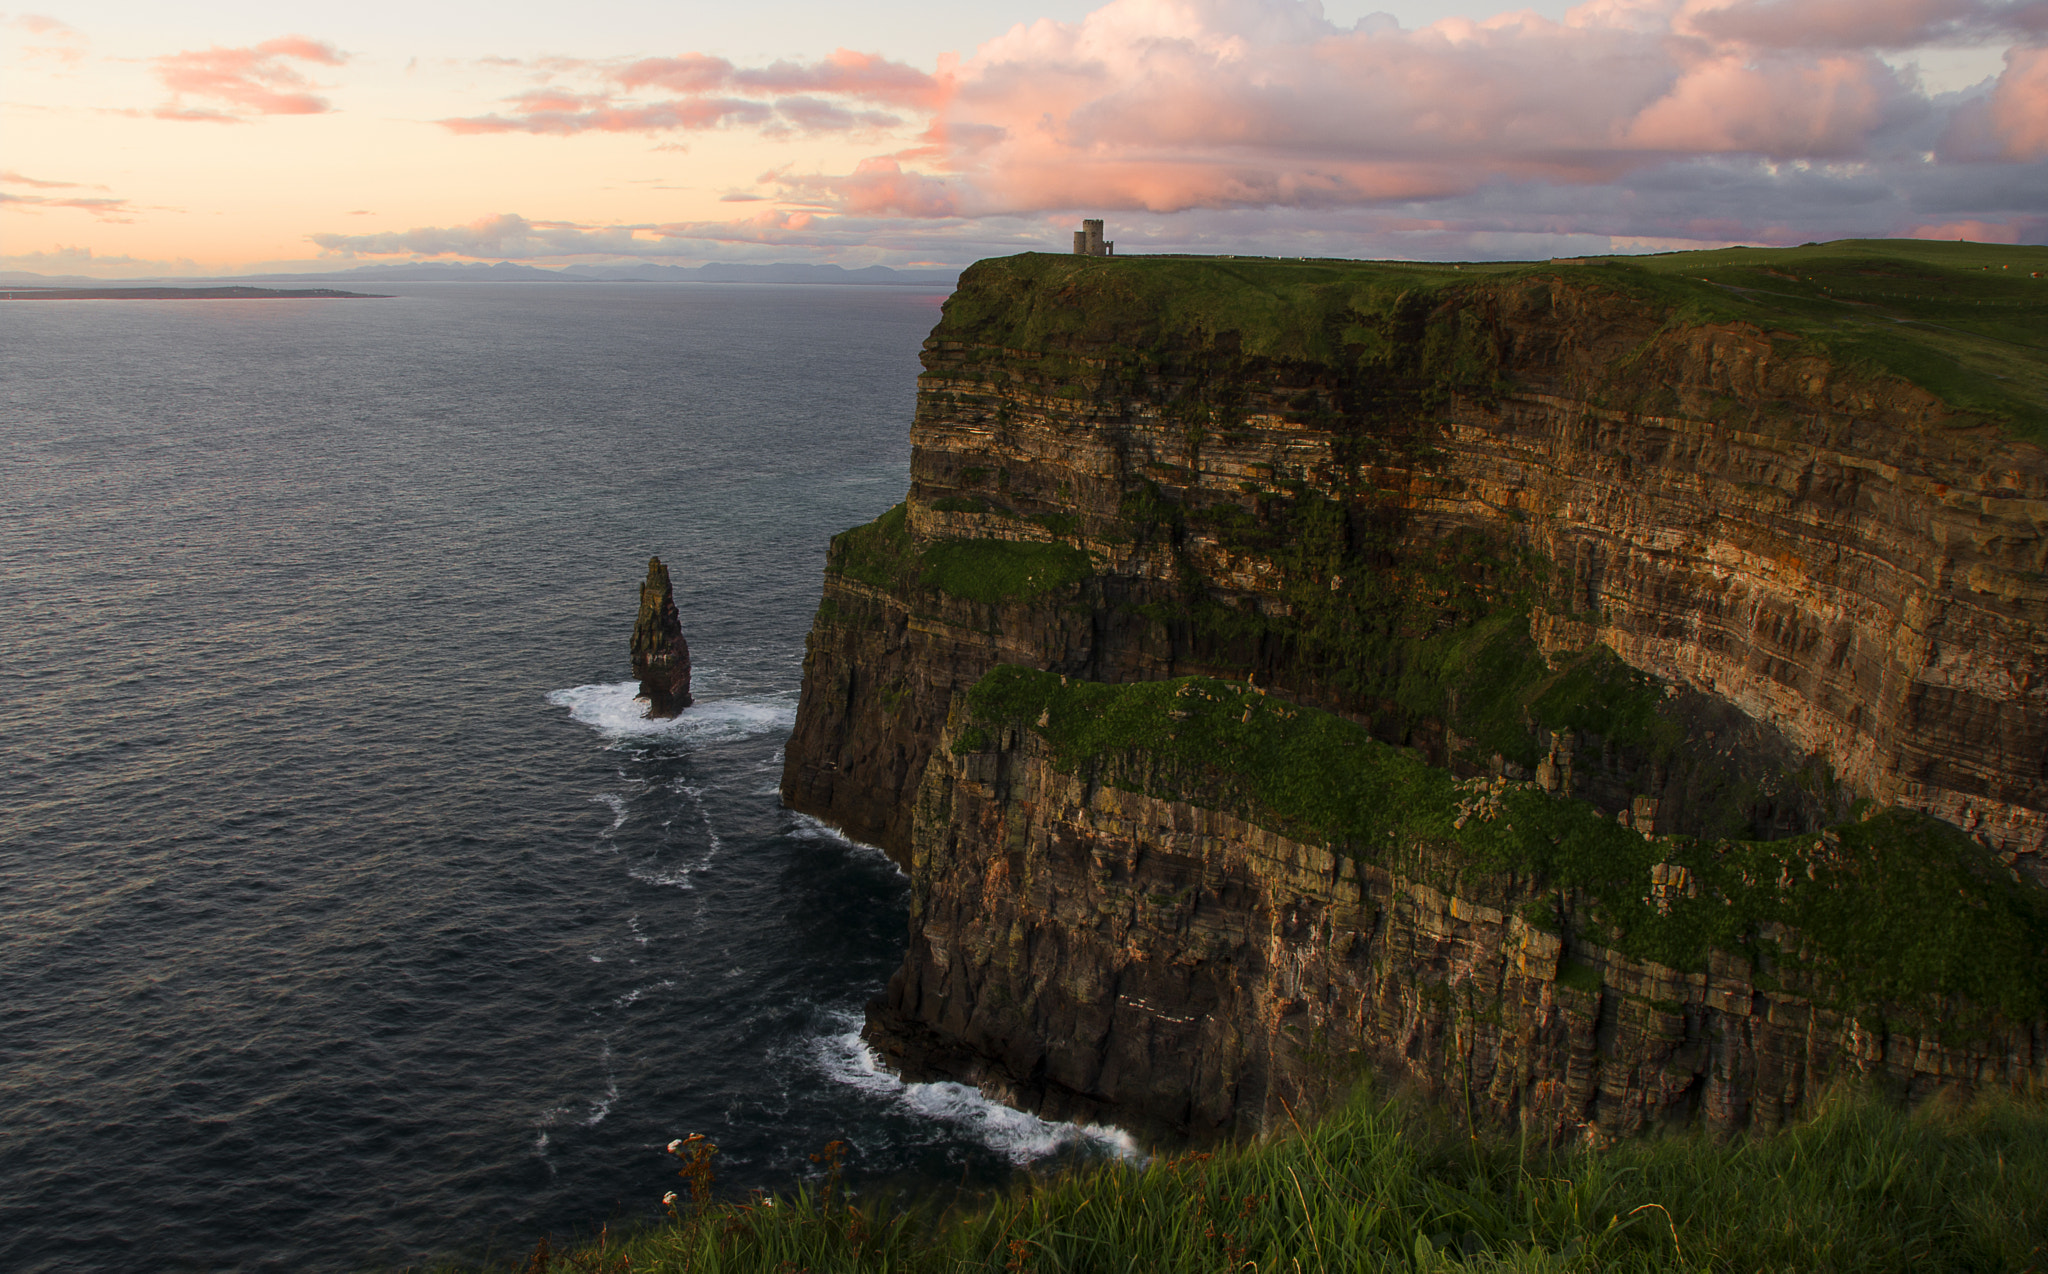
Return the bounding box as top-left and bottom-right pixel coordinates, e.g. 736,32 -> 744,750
0,260 -> 961,287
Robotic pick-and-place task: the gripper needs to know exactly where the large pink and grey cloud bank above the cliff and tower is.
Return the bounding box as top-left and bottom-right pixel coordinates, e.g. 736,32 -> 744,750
331,0 -> 2048,256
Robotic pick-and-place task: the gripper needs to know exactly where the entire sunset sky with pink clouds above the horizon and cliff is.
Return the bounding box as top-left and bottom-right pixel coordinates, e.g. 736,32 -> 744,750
0,0 -> 2048,279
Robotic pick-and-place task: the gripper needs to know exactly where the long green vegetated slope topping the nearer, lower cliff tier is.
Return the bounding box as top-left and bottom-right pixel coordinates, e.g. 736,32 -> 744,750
963,666 -> 2048,1038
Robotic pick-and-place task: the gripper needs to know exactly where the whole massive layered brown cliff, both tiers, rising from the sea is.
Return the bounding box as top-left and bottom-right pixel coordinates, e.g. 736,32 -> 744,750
782,244 -> 2048,1131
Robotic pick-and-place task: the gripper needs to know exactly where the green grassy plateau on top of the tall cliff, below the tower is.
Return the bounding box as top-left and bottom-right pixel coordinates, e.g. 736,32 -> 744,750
938,240 -> 2048,442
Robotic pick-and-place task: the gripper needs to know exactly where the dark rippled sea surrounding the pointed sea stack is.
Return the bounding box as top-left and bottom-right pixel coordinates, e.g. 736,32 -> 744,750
0,285 -> 1116,1272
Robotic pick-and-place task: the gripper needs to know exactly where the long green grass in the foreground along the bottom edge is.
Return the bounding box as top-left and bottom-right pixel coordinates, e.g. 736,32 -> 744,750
423,1090 -> 2048,1274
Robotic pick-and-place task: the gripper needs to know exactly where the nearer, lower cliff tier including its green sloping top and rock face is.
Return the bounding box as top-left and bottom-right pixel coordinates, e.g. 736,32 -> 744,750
868,668 -> 2048,1143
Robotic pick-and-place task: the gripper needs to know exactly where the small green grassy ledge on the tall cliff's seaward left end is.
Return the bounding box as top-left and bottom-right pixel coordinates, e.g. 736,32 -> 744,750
825,504 -> 1094,604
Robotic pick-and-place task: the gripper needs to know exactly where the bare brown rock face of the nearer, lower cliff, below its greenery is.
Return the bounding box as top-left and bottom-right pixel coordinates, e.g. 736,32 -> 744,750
868,708 -> 2048,1137
